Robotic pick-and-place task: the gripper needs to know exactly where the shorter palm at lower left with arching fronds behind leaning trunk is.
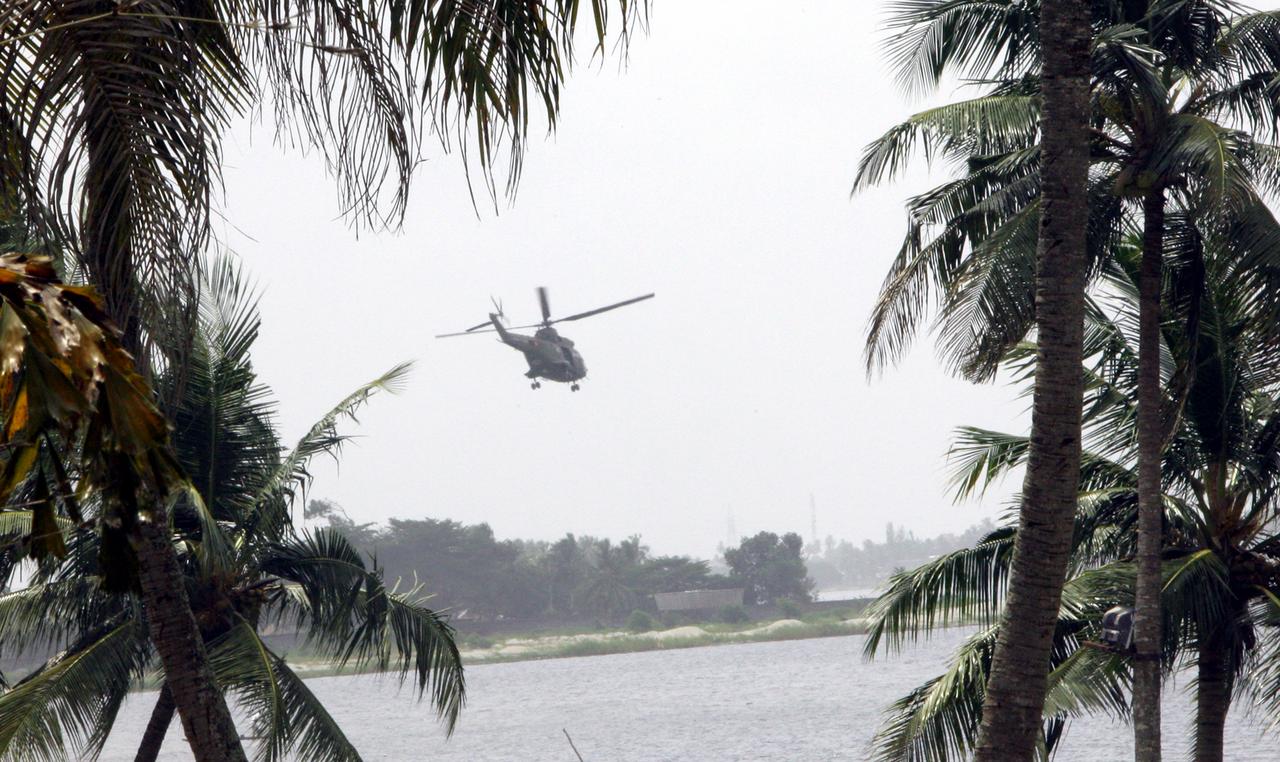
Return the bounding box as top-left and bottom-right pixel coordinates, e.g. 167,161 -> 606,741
0,261 -> 465,761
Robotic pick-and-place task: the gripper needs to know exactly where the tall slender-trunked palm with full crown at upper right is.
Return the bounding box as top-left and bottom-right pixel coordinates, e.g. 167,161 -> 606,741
859,1 -> 1280,758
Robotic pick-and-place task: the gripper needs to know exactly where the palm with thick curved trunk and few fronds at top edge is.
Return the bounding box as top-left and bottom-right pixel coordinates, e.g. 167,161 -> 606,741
860,0 -> 1091,761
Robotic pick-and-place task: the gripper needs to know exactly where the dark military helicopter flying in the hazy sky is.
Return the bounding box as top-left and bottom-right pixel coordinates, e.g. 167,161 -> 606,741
435,287 -> 654,392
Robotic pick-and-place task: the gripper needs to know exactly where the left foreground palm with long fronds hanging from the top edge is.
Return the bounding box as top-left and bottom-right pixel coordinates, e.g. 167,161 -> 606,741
0,0 -> 646,759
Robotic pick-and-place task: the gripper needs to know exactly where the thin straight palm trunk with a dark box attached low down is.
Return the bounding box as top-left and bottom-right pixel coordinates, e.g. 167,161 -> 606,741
1133,188 -> 1165,762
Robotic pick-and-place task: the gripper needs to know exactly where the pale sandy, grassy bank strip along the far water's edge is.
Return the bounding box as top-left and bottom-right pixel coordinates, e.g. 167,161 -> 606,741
285,612 -> 867,677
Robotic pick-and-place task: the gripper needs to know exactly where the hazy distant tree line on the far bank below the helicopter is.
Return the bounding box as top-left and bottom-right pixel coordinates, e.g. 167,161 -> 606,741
306,499 -> 995,619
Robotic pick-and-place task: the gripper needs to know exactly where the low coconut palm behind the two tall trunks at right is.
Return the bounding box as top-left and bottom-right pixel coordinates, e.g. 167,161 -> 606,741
868,239 -> 1280,761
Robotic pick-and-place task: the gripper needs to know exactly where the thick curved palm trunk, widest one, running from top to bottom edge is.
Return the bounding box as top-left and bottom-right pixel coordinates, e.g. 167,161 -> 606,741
974,0 -> 1089,762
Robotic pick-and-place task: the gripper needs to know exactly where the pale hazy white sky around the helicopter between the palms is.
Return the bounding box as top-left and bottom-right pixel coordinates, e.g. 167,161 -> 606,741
223,0 -> 1025,557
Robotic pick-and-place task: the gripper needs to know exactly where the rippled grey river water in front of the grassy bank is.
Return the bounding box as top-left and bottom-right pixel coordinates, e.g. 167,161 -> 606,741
102,631 -> 1277,762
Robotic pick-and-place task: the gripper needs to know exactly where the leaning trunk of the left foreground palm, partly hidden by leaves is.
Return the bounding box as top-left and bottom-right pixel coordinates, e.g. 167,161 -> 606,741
83,90 -> 246,762
